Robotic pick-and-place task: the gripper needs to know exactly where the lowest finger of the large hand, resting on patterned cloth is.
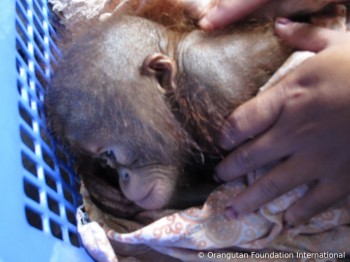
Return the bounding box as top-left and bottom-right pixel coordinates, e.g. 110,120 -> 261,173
284,174 -> 349,225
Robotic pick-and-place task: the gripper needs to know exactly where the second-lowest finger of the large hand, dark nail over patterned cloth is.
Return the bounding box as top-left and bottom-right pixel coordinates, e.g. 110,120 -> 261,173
225,156 -> 312,218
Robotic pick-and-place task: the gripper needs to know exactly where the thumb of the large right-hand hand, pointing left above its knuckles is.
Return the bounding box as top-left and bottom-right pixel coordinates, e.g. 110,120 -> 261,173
275,18 -> 338,52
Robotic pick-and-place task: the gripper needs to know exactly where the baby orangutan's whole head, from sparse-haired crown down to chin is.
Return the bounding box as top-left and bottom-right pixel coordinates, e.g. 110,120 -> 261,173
46,14 -> 200,213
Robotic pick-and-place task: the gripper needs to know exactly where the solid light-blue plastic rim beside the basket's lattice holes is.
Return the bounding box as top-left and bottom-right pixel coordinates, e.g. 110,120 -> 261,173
0,0 -> 92,262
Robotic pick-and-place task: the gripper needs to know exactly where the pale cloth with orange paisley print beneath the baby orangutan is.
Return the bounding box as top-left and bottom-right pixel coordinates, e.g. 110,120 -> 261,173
51,0 -> 350,261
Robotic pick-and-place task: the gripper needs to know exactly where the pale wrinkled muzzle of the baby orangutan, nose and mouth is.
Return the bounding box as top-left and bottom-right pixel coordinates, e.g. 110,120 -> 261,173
118,166 -> 175,210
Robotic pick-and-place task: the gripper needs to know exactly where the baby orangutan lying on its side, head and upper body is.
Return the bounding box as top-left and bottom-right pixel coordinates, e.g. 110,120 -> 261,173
46,16 -> 290,216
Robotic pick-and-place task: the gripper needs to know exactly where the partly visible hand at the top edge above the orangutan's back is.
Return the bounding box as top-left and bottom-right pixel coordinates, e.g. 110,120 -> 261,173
198,0 -> 345,30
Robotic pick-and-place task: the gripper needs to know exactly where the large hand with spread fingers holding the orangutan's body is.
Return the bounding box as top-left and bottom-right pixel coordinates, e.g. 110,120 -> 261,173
216,19 -> 350,225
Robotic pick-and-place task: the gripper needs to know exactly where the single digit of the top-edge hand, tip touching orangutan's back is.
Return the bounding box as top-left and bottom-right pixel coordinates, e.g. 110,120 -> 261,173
199,0 -> 269,30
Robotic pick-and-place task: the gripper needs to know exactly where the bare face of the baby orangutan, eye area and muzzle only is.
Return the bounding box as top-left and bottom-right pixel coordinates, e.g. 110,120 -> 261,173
81,144 -> 179,210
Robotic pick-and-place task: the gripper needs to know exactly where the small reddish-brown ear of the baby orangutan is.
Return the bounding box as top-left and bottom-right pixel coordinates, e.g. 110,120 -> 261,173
142,53 -> 177,94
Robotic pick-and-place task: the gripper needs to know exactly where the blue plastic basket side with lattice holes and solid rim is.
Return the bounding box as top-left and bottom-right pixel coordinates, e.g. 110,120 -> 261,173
0,0 -> 92,262
